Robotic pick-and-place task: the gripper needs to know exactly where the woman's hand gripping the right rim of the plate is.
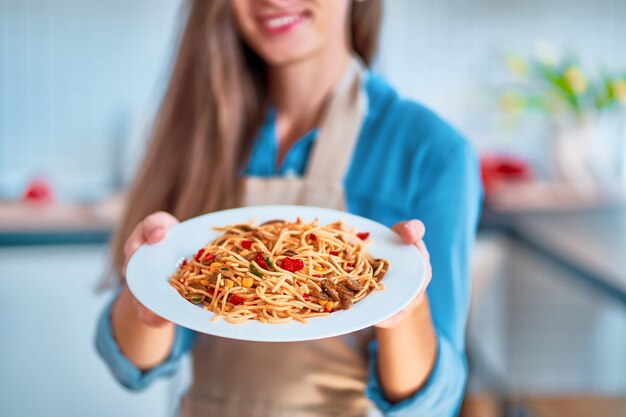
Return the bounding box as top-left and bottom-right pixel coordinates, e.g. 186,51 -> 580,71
375,220 -> 432,329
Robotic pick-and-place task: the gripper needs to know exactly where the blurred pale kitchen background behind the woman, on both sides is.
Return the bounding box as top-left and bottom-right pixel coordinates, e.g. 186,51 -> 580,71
0,0 -> 626,417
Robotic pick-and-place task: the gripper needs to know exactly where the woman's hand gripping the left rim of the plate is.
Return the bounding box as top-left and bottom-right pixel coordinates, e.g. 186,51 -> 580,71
120,211 -> 179,327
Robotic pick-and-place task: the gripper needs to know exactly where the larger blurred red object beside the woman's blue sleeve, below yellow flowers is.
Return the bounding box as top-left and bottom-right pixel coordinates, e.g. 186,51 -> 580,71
480,155 -> 533,196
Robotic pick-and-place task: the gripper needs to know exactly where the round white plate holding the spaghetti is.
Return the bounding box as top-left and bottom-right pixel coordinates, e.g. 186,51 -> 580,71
126,206 -> 426,342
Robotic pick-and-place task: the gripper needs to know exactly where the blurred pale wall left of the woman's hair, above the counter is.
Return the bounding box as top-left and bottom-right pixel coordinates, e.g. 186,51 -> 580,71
0,0 -> 180,199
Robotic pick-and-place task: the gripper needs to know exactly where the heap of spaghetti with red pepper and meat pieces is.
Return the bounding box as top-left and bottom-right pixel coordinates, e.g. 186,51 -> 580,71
170,218 -> 389,323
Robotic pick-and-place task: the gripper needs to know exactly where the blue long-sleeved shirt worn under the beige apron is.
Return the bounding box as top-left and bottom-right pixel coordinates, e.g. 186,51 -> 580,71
96,74 -> 482,417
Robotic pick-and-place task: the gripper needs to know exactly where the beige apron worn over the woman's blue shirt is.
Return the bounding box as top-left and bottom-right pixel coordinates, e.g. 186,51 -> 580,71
181,59 -> 372,417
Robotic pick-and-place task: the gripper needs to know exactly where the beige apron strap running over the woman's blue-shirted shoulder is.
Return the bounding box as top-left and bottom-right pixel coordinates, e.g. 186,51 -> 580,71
305,56 -> 368,185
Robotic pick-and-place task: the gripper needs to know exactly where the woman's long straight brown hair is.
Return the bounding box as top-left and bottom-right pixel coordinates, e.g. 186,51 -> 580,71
111,0 -> 382,279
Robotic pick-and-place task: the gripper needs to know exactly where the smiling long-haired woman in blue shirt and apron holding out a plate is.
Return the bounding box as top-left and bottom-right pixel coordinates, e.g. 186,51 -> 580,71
97,0 -> 480,416
